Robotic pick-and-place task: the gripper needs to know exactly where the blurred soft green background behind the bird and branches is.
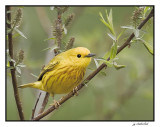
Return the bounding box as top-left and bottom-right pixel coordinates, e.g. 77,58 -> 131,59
6,6 -> 154,120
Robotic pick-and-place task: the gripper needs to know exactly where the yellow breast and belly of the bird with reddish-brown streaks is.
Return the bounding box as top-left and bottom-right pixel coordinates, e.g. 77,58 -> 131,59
42,66 -> 86,94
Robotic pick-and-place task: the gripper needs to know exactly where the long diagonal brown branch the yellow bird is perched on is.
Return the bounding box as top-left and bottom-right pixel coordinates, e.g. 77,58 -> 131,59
33,9 -> 153,120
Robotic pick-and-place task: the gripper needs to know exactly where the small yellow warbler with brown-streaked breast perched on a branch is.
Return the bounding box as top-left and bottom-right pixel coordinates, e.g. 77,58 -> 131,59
19,47 -> 95,96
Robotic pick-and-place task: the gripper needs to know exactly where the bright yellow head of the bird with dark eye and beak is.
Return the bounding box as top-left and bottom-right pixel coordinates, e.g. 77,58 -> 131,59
64,47 -> 95,68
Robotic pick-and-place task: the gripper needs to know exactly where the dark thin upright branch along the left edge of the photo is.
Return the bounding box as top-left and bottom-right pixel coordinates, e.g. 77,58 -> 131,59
6,6 -> 24,120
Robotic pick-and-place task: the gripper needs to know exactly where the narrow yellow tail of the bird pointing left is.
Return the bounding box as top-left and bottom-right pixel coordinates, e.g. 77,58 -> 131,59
18,81 -> 42,89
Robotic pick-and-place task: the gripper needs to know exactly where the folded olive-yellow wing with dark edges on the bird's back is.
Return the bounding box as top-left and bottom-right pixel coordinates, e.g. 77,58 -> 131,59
38,61 -> 59,81
